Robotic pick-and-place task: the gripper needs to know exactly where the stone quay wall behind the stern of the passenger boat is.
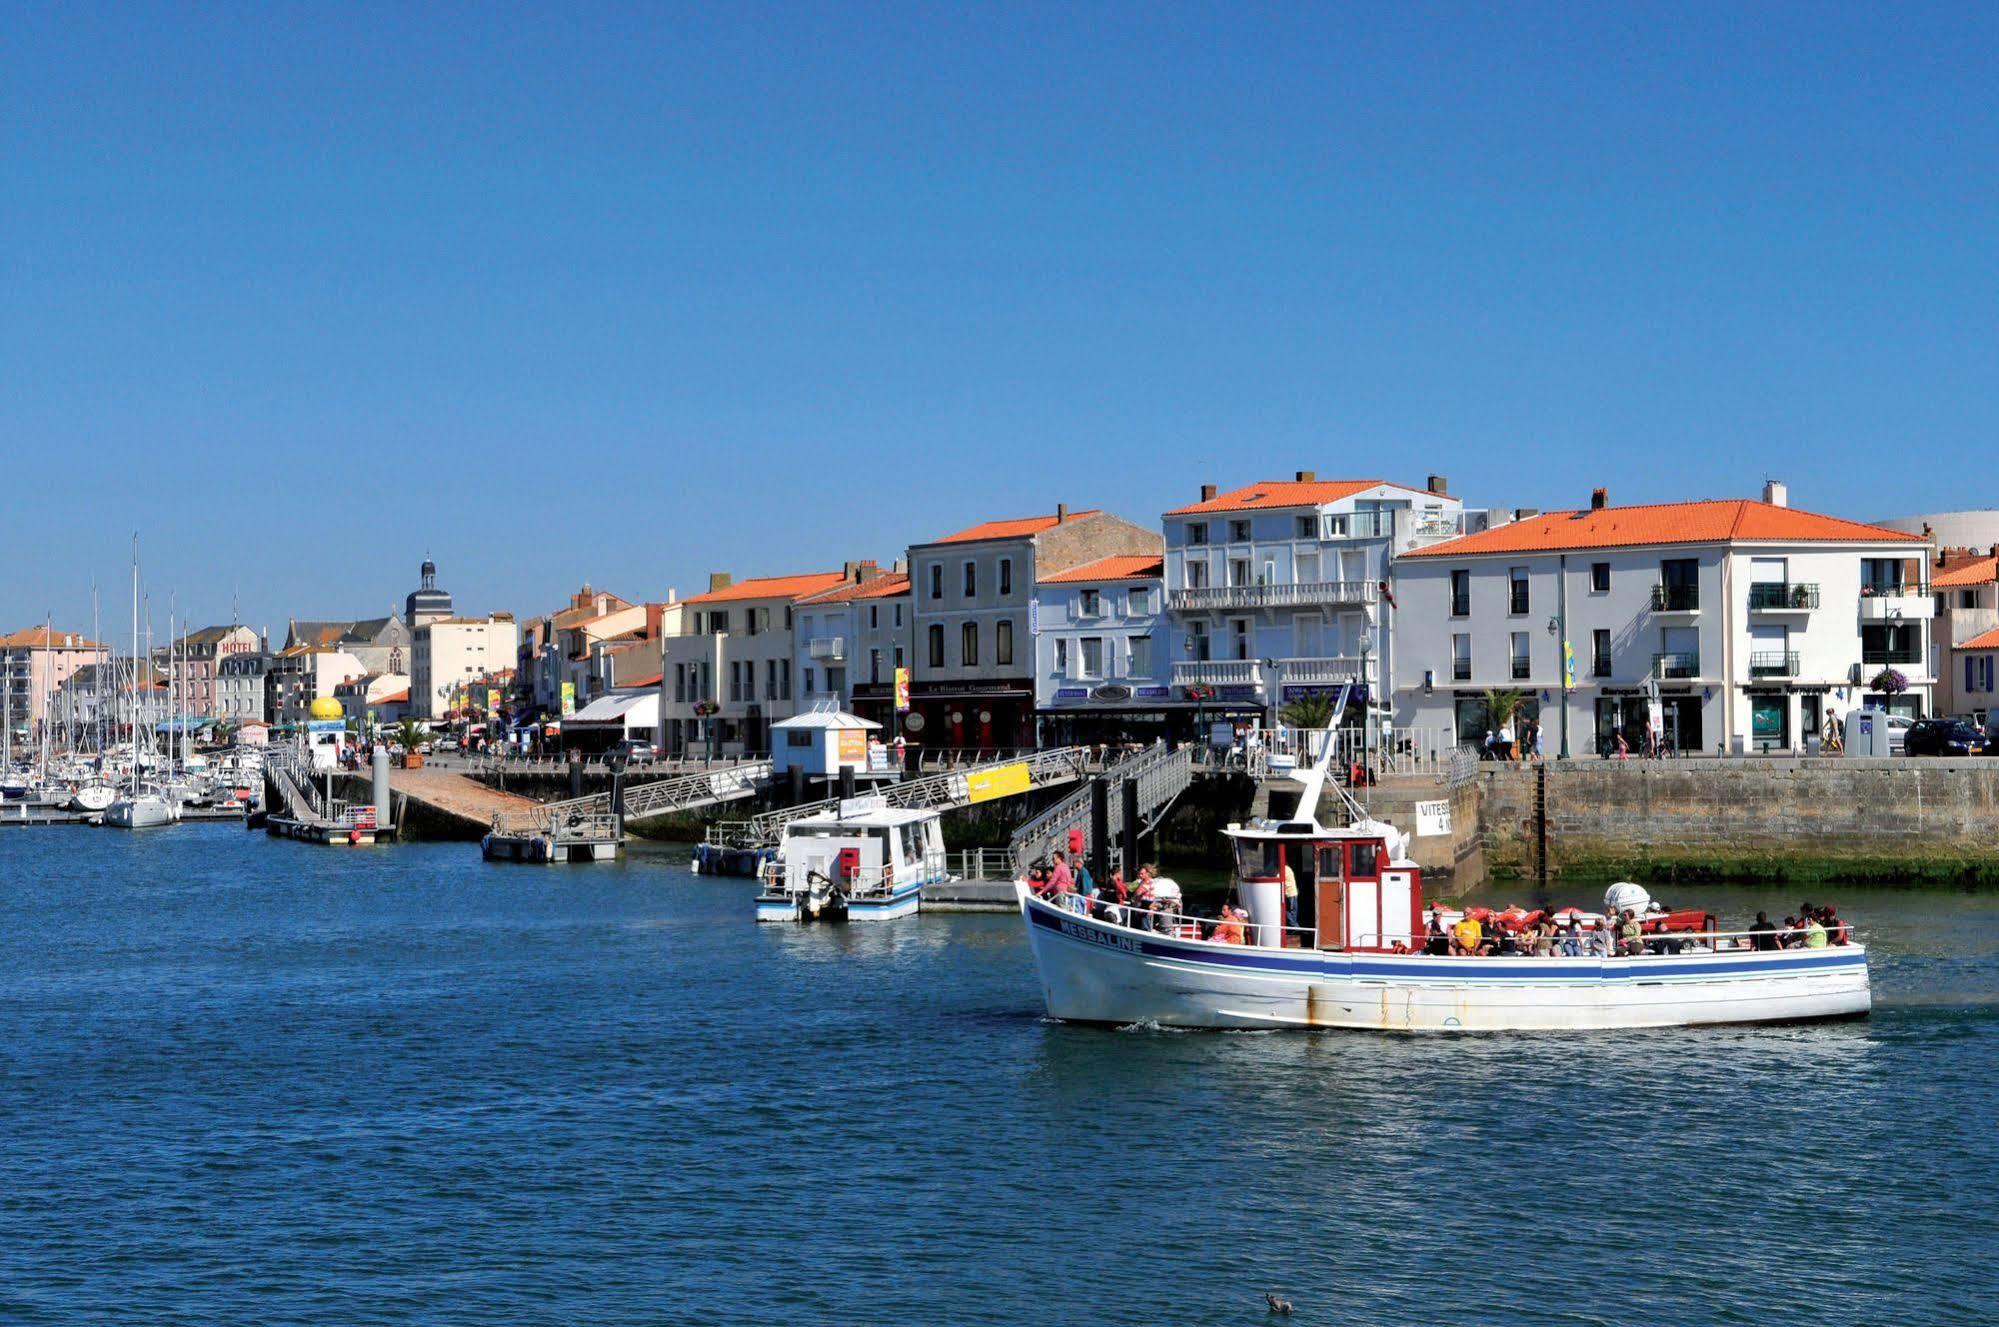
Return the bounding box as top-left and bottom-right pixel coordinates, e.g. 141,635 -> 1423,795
1477,757 -> 1999,887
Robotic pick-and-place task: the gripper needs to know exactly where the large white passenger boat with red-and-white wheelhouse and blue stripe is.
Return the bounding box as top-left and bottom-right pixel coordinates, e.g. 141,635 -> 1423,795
1015,727 -> 1871,1031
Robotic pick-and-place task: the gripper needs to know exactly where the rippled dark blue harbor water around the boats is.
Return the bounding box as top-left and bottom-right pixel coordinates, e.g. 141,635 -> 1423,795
0,825 -> 1999,1325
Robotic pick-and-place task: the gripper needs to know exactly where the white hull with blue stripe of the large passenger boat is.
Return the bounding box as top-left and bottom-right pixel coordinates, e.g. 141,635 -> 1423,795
1017,885 -> 1871,1031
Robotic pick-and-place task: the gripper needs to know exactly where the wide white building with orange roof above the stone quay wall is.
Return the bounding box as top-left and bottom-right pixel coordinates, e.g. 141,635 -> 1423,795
1393,484 -> 1935,755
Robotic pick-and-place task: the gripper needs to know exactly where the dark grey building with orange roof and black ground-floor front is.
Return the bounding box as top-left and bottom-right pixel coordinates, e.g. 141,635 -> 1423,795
902,506 -> 1159,749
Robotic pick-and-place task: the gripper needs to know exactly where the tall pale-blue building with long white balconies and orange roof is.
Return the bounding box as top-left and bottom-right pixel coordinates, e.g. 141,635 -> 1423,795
1163,470 -> 1487,725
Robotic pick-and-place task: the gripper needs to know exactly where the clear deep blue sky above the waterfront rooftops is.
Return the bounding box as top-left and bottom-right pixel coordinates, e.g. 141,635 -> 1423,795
0,4 -> 1999,630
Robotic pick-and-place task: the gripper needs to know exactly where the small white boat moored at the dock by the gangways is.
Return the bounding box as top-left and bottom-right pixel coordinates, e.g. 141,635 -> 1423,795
756,797 -> 952,921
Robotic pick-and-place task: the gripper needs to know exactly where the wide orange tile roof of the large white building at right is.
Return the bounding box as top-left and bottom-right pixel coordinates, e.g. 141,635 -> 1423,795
1403,498 -> 1923,558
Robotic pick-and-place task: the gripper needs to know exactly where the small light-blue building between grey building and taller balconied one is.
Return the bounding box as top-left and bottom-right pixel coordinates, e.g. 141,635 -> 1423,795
1029,554 -> 1185,745
